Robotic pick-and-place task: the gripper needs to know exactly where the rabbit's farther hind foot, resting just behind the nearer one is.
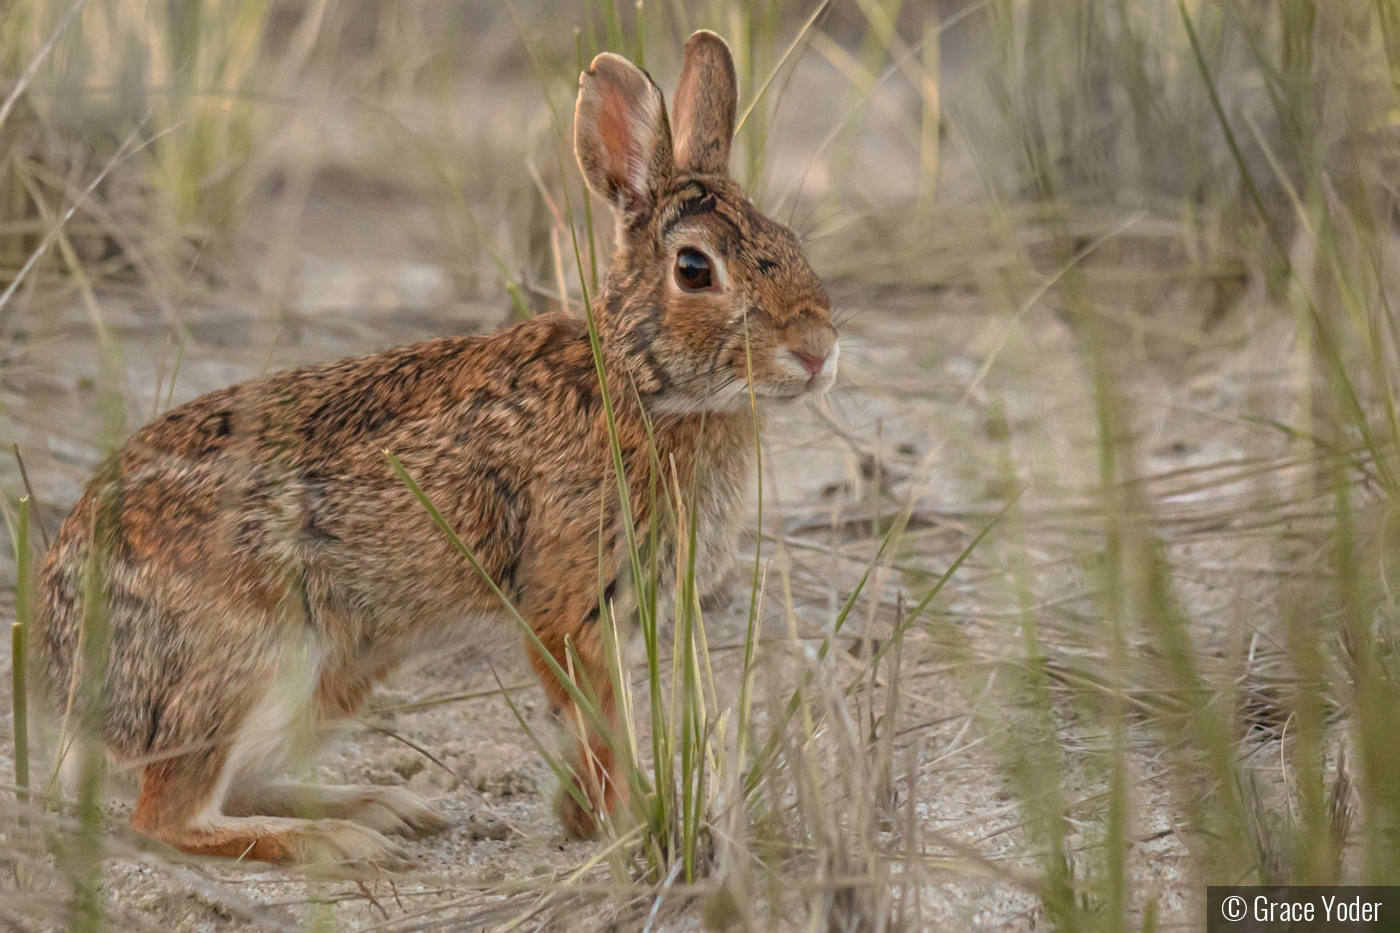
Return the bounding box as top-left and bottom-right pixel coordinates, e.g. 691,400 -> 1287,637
224,782 -> 447,839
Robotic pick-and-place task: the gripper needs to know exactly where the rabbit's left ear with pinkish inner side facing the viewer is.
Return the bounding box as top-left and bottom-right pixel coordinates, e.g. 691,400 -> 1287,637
574,52 -> 675,214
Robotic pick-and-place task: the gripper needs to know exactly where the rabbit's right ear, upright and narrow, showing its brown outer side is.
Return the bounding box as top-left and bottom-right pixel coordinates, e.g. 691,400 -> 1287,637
675,29 -> 739,175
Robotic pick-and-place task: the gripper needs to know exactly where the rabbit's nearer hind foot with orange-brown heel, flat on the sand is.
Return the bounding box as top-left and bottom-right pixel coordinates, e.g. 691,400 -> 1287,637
132,748 -> 409,867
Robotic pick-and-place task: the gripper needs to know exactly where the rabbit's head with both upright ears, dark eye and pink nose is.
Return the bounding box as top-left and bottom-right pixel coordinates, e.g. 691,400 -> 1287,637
574,32 -> 837,412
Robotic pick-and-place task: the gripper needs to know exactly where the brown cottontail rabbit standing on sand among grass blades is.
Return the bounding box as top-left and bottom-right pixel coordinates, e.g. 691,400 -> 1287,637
32,31 -> 839,866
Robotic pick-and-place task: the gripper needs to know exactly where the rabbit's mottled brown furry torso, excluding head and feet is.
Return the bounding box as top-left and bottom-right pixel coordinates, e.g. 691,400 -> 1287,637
34,315 -> 688,755
